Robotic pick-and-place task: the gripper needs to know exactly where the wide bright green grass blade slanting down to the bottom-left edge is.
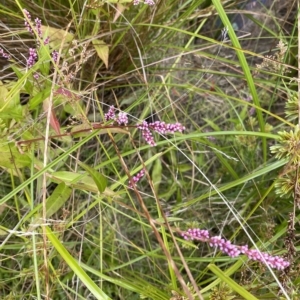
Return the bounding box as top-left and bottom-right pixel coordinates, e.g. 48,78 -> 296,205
45,226 -> 111,300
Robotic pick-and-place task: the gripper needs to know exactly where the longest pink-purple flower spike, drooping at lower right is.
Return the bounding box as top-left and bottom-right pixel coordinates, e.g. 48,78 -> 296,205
182,228 -> 290,270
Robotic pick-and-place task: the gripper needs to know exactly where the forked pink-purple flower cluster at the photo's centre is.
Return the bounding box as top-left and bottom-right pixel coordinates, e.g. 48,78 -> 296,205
137,121 -> 185,146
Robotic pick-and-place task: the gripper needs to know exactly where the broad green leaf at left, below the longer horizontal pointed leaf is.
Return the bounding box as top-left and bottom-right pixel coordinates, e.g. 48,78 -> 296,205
46,182 -> 72,218
